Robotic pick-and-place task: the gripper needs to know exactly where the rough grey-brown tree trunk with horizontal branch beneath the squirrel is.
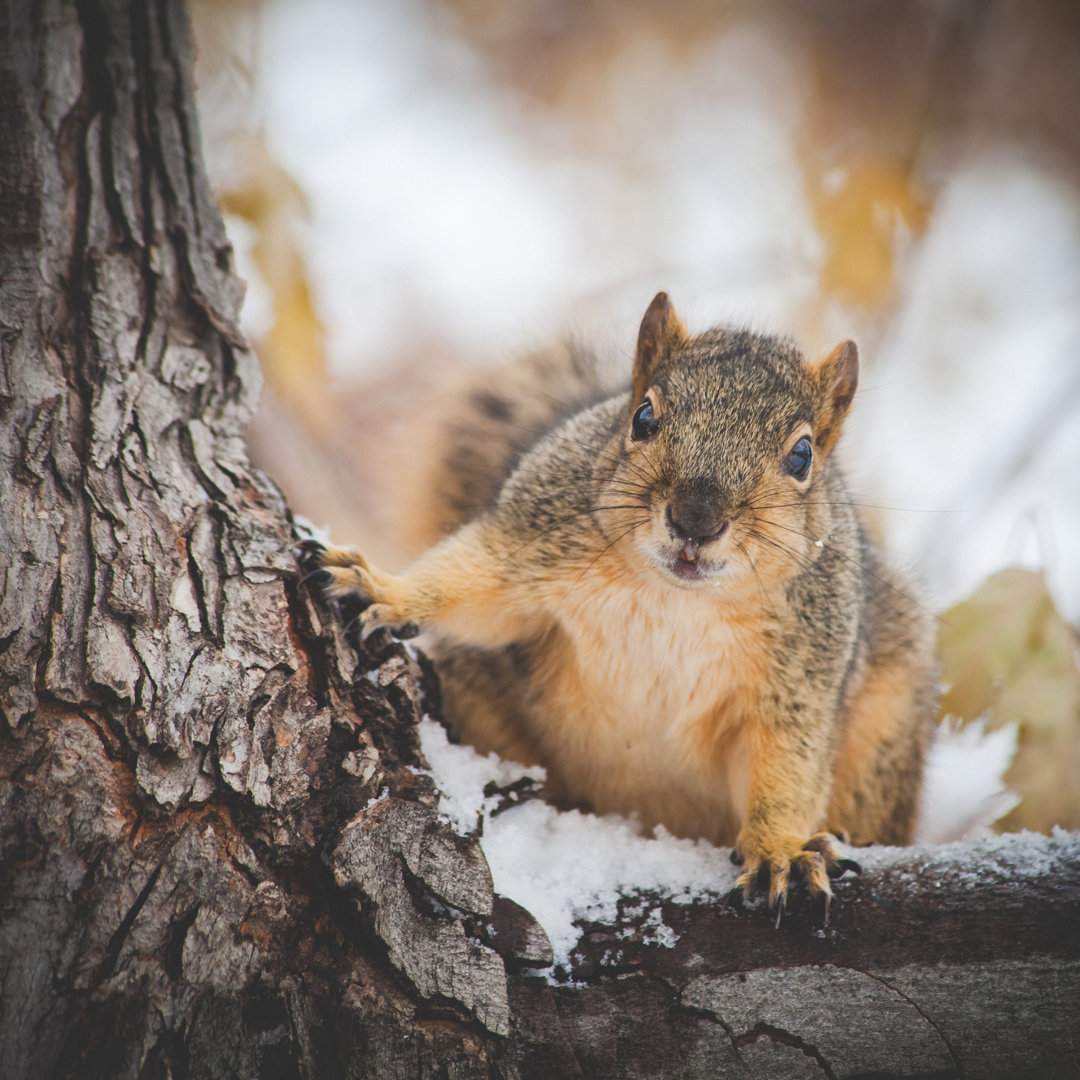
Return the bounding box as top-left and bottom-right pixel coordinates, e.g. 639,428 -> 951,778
0,0 -> 1080,1080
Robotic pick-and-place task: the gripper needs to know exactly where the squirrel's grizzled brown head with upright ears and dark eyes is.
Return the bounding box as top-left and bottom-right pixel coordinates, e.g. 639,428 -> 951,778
616,293 -> 859,588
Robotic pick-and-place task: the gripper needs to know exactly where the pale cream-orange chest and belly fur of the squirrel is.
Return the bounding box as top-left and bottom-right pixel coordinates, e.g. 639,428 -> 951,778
537,565 -> 764,842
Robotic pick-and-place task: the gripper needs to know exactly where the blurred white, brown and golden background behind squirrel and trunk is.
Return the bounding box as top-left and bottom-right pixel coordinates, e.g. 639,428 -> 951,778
189,0 -> 1080,828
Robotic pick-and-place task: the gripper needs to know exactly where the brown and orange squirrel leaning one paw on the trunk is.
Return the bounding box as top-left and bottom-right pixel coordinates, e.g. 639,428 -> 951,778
308,293 -> 936,907
